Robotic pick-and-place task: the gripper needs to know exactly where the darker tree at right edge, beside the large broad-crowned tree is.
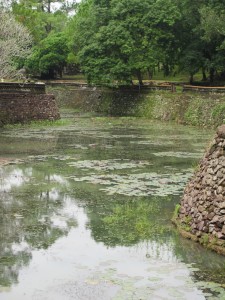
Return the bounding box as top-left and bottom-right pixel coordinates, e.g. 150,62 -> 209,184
177,0 -> 225,83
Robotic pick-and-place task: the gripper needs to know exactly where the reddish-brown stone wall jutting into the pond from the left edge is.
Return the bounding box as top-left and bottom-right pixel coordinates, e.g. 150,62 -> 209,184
0,92 -> 60,125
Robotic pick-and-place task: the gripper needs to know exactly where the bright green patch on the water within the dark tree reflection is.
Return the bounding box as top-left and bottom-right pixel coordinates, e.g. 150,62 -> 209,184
87,199 -> 167,247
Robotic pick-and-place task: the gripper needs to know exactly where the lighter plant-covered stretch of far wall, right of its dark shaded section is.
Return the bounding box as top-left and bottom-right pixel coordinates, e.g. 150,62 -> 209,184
135,92 -> 225,128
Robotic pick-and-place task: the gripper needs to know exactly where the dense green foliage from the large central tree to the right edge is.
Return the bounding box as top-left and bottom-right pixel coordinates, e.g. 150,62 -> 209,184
67,0 -> 225,84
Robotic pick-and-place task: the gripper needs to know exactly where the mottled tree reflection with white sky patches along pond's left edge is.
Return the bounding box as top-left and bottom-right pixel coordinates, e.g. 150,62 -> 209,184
0,167 -> 77,286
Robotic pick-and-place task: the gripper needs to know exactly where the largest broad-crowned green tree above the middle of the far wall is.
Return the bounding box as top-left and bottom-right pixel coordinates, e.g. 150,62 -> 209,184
73,0 -> 180,84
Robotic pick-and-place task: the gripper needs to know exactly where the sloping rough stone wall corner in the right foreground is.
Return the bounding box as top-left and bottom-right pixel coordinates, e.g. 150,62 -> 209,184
177,125 -> 225,252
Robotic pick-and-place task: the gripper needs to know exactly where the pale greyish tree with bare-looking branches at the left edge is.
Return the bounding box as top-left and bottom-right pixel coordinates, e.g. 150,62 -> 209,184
0,12 -> 32,78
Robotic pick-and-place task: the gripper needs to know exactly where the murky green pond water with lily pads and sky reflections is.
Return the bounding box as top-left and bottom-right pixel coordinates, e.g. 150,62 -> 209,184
0,112 -> 225,300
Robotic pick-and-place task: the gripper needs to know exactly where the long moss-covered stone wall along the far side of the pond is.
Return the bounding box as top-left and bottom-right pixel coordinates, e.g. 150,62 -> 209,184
49,86 -> 225,128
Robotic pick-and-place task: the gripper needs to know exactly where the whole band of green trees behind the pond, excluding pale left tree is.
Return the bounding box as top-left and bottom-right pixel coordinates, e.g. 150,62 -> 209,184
3,0 -> 225,84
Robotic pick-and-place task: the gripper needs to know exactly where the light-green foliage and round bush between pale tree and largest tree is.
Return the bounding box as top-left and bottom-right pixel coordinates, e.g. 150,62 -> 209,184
12,0 -> 75,78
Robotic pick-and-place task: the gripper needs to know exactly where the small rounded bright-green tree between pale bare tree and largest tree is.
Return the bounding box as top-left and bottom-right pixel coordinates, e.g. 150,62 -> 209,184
26,33 -> 69,79
